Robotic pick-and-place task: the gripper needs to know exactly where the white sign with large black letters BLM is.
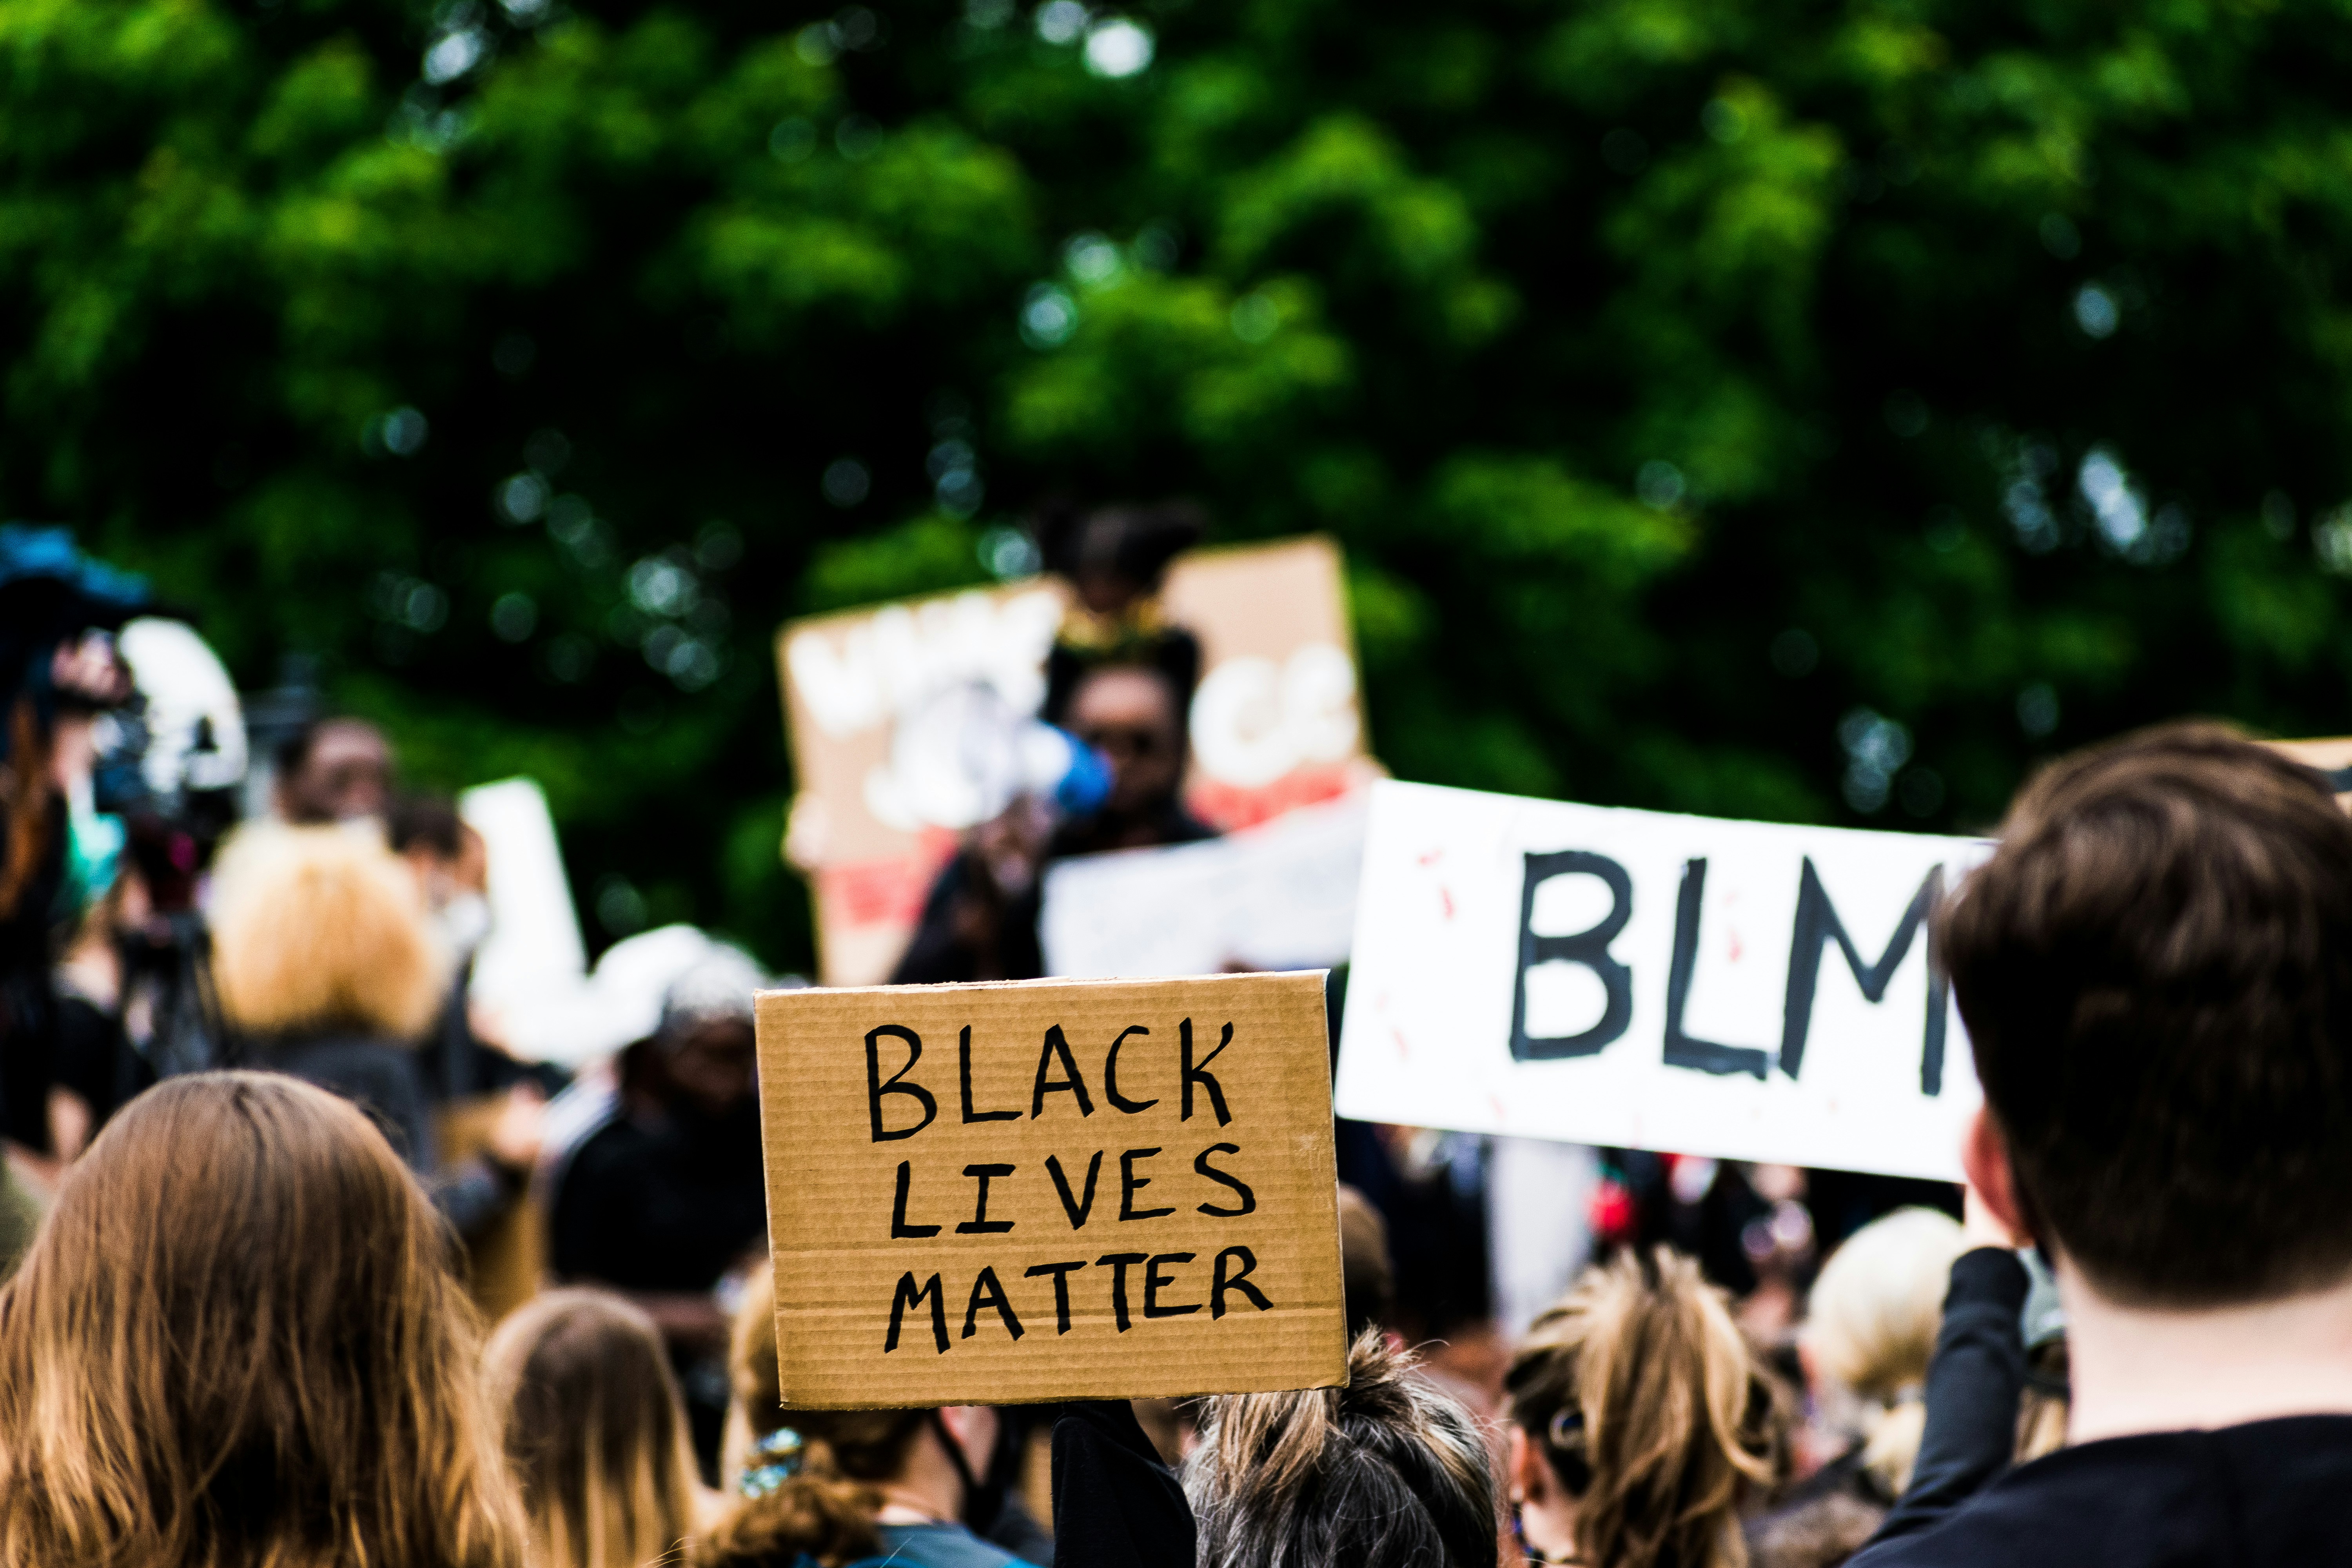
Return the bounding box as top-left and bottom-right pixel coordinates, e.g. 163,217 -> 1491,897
1338,783 -> 1987,1180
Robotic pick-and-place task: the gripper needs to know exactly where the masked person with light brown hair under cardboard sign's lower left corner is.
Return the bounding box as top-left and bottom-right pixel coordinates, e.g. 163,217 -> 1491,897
694,1269 -> 1051,1568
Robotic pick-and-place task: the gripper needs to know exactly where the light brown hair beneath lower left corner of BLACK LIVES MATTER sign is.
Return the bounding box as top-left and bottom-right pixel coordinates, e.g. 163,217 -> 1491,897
689,1267 -> 898,1568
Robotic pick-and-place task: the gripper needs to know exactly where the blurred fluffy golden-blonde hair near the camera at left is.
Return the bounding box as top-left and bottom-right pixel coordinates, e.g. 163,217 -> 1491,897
212,828 -> 449,1039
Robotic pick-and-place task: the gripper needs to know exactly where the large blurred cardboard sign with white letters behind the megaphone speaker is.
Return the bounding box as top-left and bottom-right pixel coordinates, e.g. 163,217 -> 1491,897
776,538 -> 1367,985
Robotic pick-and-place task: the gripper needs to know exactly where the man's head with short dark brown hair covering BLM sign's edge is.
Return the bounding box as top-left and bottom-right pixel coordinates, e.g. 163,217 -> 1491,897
1938,724 -> 2352,1309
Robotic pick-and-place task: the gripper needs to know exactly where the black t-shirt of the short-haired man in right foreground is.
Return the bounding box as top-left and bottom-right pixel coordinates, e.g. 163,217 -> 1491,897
1853,1415 -> 2352,1568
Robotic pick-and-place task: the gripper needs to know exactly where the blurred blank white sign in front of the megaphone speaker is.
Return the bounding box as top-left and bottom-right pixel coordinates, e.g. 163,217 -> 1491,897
1037,790 -> 1367,978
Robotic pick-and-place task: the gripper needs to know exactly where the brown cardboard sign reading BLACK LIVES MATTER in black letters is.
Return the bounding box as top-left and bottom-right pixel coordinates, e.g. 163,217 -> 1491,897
760,971 -> 1348,1408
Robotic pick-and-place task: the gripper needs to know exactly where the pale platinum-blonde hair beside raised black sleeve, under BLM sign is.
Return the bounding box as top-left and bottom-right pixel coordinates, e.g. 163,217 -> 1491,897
1804,1208 -> 1969,1497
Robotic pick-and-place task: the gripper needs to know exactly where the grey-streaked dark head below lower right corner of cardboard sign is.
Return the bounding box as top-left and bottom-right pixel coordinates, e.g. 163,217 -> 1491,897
1185,1333 -> 1501,1568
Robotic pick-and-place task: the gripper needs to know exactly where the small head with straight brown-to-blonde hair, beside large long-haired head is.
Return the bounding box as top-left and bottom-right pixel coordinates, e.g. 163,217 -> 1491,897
482,1290 -> 694,1568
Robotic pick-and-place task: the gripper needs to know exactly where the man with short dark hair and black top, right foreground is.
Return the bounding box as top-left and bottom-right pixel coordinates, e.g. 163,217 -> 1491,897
1853,724 -> 2352,1568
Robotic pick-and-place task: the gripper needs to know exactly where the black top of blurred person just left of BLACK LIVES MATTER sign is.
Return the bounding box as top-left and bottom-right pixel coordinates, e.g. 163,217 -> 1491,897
550,1100 -> 767,1293
